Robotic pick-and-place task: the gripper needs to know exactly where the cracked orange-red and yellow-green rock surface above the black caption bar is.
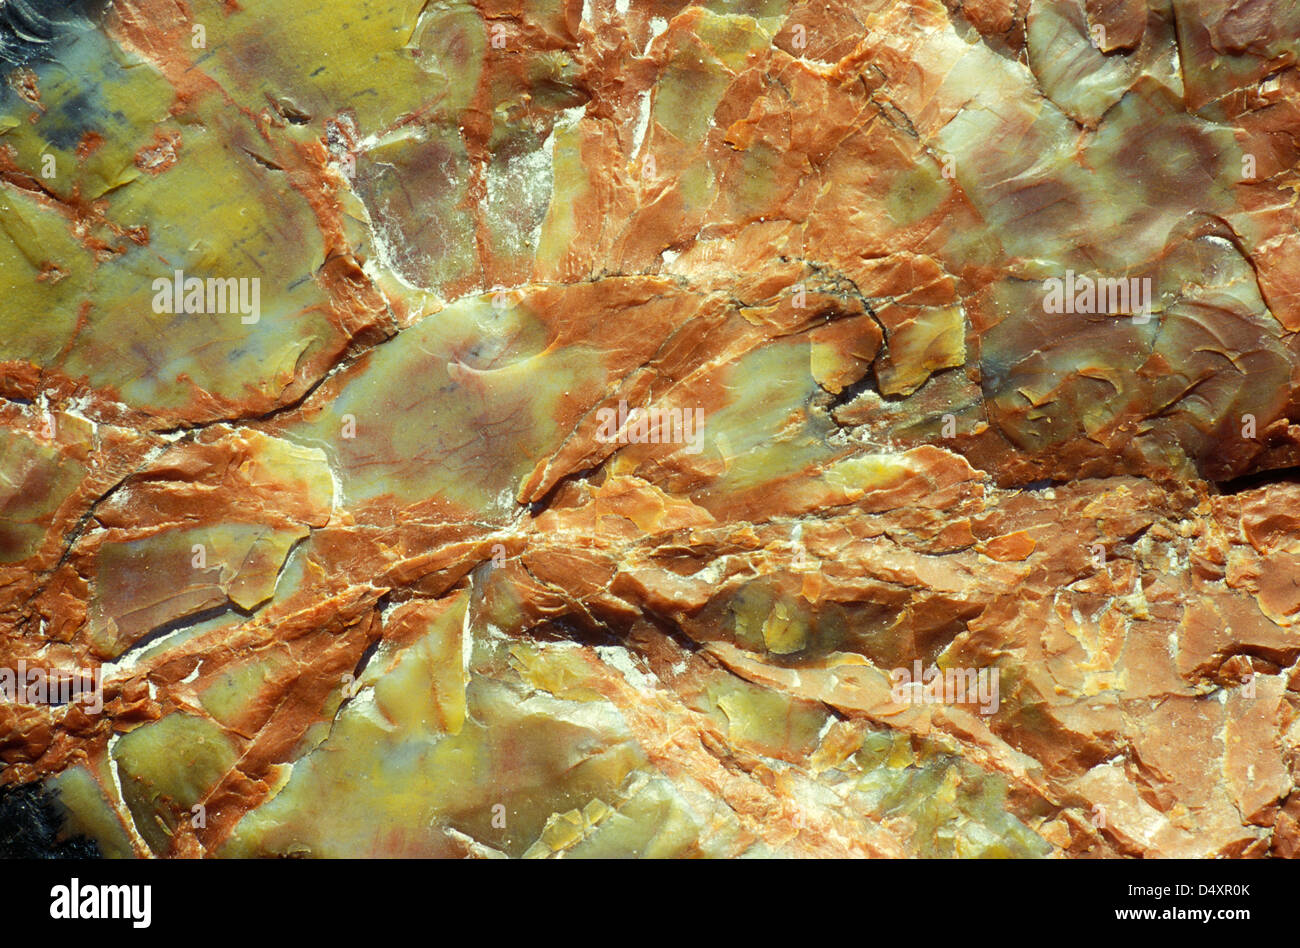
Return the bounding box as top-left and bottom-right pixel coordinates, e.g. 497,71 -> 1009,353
0,0 -> 1300,857
